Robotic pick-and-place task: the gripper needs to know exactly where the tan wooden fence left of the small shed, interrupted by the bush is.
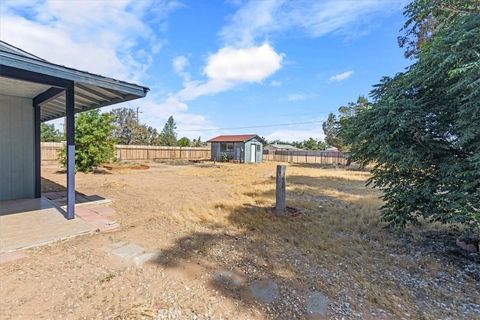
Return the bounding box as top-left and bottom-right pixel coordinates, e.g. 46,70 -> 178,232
41,142 -> 210,164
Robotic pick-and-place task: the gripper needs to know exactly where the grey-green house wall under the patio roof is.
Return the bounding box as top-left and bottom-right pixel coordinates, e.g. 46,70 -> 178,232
0,95 -> 35,200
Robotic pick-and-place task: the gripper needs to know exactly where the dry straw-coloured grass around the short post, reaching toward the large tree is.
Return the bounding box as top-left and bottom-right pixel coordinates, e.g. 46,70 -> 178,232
166,164 -> 478,318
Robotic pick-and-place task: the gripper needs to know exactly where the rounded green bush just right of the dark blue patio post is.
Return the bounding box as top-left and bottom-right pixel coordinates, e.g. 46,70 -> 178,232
60,110 -> 115,172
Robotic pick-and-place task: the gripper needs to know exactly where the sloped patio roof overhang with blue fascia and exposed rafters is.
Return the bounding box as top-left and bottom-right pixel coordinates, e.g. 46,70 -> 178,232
0,40 -> 150,121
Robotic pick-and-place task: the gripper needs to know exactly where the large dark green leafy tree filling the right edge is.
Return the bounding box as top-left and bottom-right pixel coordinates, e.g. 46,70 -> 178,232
342,0 -> 480,233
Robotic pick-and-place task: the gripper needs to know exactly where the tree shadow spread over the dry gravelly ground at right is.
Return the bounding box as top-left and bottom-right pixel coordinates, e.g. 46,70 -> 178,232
151,172 -> 480,319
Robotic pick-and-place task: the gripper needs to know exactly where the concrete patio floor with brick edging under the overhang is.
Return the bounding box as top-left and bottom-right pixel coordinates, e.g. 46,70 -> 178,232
0,198 -> 119,253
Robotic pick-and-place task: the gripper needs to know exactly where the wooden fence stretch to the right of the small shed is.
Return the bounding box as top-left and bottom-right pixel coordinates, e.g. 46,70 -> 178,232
263,150 -> 348,165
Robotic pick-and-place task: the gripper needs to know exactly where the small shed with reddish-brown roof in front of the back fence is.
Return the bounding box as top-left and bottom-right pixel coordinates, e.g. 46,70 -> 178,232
207,134 -> 263,163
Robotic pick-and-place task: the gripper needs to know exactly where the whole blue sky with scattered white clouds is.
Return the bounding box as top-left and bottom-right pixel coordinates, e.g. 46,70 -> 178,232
0,0 -> 411,141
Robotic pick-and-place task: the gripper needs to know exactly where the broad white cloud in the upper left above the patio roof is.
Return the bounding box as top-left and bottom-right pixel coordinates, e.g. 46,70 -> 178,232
0,0 -> 180,82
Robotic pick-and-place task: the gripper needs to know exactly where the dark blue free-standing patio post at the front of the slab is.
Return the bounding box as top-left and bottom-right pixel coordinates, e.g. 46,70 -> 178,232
65,82 -> 75,219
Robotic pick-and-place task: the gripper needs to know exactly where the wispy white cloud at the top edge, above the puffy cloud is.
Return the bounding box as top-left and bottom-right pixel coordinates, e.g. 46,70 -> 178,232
220,0 -> 407,45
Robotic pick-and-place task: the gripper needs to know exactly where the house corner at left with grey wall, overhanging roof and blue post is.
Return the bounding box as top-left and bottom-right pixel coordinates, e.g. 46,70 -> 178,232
0,41 -> 149,219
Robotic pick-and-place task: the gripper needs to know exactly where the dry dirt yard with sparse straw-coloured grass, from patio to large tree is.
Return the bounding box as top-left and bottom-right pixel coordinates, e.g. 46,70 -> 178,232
0,163 -> 480,319
